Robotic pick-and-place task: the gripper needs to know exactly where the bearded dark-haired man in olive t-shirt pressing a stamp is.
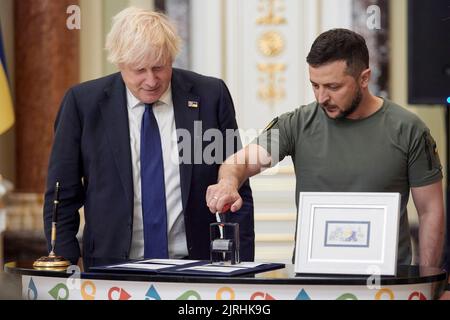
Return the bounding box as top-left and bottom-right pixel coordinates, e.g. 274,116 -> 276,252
206,29 -> 444,267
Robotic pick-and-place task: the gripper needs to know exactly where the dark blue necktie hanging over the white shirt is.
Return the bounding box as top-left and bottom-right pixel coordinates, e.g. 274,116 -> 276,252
141,104 -> 169,259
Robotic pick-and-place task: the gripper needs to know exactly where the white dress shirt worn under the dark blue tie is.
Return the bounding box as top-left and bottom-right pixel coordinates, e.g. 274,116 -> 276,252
127,86 -> 188,259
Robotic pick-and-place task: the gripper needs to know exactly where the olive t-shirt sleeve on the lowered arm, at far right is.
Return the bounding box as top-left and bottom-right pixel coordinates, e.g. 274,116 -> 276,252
408,125 -> 442,187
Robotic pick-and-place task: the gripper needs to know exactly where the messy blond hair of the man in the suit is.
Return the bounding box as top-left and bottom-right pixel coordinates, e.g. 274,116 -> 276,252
106,7 -> 181,67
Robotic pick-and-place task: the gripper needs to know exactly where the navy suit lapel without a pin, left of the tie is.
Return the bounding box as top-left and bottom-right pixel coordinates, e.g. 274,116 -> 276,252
99,74 -> 134,214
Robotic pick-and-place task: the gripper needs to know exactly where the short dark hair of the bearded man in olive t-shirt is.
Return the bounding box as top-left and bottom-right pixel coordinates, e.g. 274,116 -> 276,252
306,29 -> 369,76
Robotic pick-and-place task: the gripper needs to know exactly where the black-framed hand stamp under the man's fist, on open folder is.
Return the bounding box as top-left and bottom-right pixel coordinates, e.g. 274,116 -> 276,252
209,222 -> 240,264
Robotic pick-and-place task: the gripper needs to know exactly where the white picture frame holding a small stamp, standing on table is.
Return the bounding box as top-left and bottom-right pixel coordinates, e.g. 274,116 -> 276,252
295,192 -> 400,276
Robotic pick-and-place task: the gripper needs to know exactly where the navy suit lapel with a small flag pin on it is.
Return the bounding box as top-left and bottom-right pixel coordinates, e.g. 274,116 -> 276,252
172,69 -> 201,210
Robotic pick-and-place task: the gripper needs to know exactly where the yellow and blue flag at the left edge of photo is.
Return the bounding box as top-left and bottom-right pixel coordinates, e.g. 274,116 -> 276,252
0,22 -> 14,134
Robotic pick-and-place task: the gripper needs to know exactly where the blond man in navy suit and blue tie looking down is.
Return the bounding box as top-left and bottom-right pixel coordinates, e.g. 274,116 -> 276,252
44,8 -> 254,266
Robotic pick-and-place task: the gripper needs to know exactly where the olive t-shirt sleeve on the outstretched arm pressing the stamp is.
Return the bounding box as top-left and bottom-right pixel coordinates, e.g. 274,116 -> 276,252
251,111 -> 298,165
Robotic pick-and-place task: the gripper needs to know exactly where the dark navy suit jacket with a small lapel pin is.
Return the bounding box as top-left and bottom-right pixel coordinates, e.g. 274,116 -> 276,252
44,68 -> 254,267
